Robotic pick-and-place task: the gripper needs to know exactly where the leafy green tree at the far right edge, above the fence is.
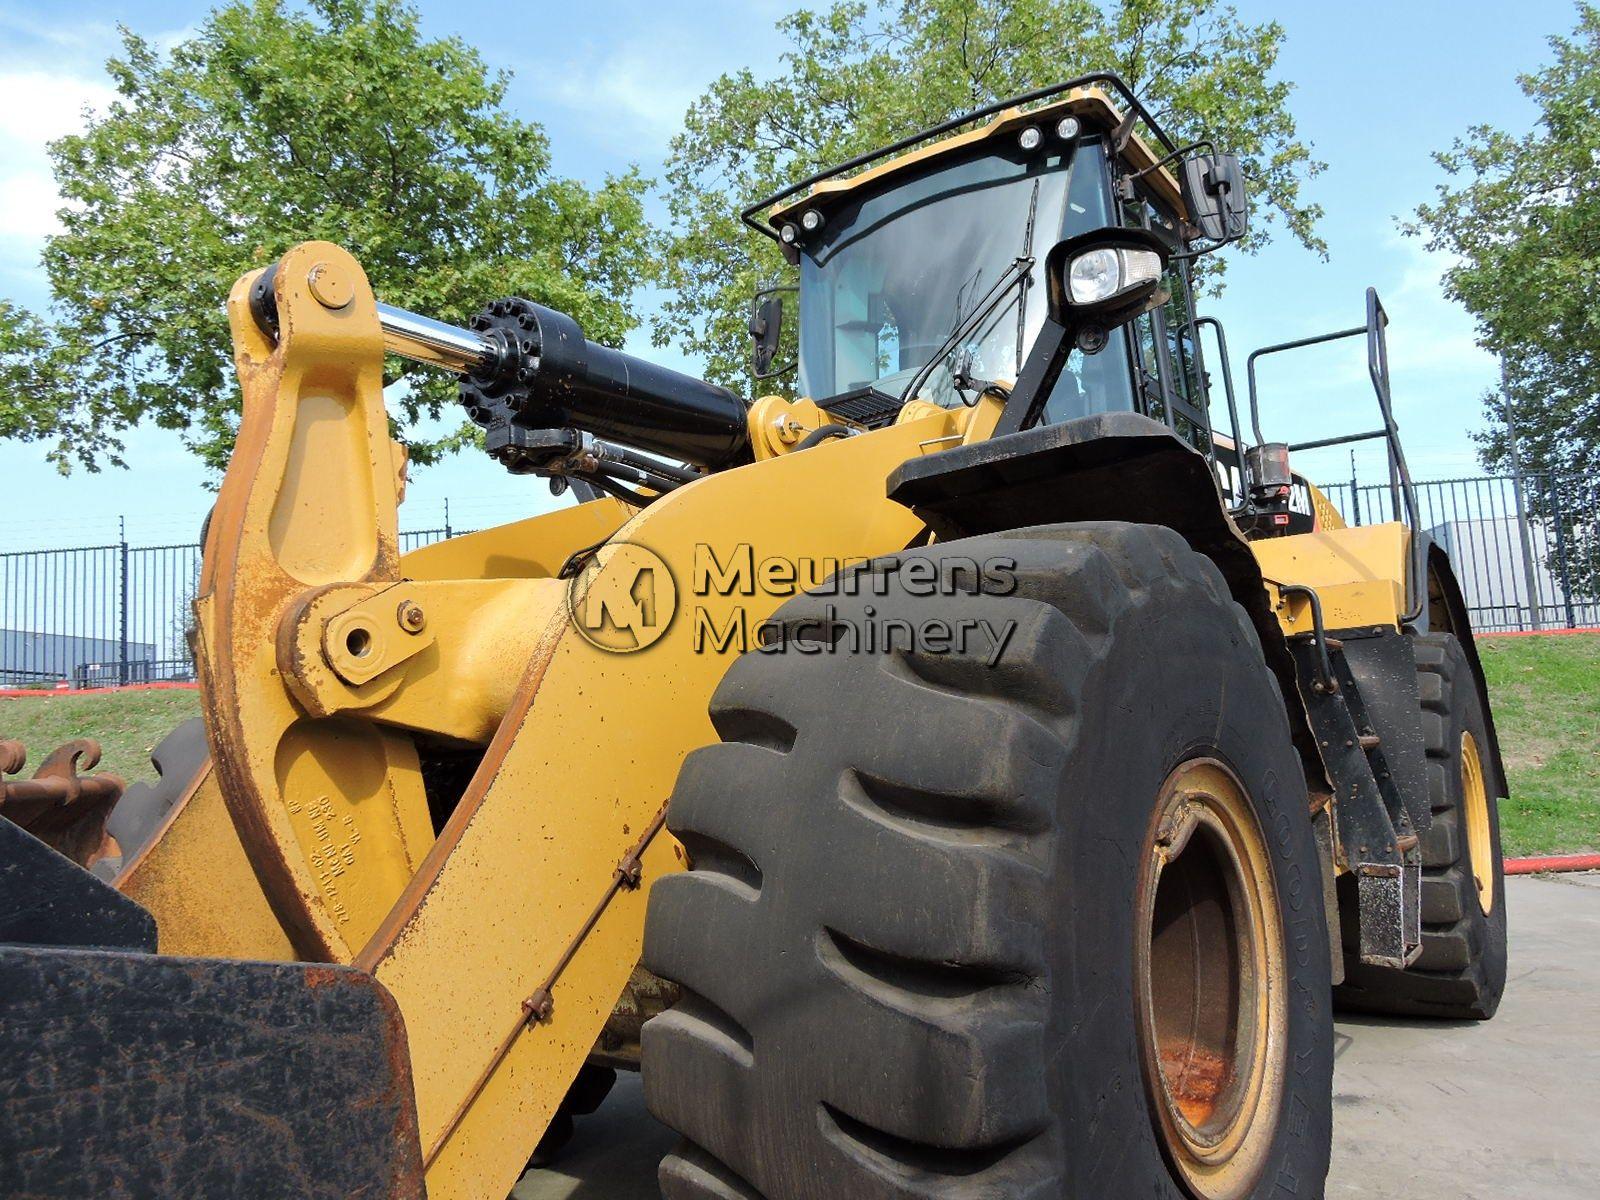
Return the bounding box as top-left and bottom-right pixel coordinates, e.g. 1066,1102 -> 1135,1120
1408,3 -> 1600,483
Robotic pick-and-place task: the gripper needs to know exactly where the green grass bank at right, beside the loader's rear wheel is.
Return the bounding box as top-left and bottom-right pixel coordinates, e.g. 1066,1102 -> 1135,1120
1478,634 -> 1600,856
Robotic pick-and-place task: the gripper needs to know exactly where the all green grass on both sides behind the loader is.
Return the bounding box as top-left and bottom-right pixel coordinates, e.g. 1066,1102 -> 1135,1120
0,634 -> 1600,856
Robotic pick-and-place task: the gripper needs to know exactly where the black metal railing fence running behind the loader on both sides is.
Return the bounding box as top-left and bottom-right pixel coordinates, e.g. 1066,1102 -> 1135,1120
0,475 -> 1600,688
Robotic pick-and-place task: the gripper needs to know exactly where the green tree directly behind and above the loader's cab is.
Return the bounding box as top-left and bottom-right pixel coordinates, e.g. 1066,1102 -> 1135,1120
653,0 -> 1325,387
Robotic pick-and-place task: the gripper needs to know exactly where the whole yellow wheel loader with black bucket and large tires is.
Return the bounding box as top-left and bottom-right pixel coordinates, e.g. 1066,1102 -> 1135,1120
0,75 -> 1506,1200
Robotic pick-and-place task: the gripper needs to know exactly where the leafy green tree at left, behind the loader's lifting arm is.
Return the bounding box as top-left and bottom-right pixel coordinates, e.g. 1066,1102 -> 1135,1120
0,0 -> 650,470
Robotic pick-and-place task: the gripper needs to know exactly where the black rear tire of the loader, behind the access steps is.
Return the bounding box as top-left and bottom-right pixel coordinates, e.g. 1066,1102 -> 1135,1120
1334,634 -> 1506,1021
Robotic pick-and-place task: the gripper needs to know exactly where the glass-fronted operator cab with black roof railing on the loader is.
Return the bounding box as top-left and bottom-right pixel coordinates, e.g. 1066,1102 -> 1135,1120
747,90 -> 1230,474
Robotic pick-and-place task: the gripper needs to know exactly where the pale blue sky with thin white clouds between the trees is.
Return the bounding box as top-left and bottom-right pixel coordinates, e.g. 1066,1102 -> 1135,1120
0,0 -> 1574,550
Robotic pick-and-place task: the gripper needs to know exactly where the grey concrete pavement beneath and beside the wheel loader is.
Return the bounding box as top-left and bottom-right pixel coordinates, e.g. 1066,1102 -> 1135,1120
514,874 -> 1600,1200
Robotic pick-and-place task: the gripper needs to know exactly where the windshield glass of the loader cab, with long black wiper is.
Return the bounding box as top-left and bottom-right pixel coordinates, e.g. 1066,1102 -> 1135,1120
800,142 -> 1133,421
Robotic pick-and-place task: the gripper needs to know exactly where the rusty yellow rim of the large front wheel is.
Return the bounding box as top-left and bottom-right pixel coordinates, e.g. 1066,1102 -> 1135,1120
1134,758 -> 1288,1200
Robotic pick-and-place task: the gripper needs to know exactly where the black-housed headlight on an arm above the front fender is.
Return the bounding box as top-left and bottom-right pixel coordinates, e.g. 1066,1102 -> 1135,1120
1045,229 -> 1171,352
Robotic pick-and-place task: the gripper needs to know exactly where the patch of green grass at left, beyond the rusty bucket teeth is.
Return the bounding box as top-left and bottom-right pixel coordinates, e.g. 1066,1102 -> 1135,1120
0,690 -> 200,784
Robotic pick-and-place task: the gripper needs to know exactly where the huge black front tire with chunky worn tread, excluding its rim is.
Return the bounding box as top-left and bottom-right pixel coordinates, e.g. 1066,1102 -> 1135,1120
643,523 -> 1333,1200
